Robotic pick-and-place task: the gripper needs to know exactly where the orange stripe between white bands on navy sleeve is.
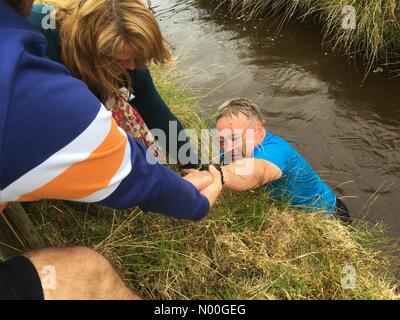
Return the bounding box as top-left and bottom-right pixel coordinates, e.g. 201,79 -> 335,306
18,120 -> 128,201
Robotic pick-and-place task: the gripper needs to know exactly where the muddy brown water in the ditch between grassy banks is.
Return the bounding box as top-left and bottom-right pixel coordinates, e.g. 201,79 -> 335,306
152,0 -> 400,237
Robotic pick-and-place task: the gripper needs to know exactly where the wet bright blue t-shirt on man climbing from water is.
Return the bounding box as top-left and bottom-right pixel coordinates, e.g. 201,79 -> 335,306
254,132 -> 336,215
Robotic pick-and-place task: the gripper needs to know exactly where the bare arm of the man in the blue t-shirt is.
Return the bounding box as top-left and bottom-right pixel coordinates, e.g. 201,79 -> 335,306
222,158 -> 282,192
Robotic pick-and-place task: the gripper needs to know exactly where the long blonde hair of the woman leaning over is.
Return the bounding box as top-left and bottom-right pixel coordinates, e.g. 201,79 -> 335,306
47,0 -> 172,99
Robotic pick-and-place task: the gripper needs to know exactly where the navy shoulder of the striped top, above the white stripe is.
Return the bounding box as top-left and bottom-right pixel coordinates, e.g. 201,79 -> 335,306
0,43 -> 103,189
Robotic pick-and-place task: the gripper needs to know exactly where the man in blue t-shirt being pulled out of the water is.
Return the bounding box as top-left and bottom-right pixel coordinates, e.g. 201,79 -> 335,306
216,98 -> 350,222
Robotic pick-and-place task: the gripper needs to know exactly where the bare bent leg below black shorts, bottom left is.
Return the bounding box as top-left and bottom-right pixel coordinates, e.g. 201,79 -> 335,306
25,247 -> 140,300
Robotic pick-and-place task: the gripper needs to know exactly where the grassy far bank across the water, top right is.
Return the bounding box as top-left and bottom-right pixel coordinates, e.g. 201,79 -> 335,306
212,0 -> 400,73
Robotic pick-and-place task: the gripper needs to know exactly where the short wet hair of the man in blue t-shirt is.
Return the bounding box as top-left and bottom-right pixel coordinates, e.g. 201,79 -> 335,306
216,97 -> 263,121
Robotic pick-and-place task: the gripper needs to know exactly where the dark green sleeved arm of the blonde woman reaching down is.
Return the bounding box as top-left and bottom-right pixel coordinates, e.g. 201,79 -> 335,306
131,68 -> 199,168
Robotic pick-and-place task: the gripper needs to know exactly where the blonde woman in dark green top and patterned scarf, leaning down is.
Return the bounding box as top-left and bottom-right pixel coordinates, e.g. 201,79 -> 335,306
29,0 -> 198,169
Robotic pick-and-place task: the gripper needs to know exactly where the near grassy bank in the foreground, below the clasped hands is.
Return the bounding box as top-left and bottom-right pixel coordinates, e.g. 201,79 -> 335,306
26,65 -> 400,299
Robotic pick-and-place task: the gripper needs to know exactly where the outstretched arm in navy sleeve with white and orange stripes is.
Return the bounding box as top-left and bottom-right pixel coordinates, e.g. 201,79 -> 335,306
0,37 -> 218,220
